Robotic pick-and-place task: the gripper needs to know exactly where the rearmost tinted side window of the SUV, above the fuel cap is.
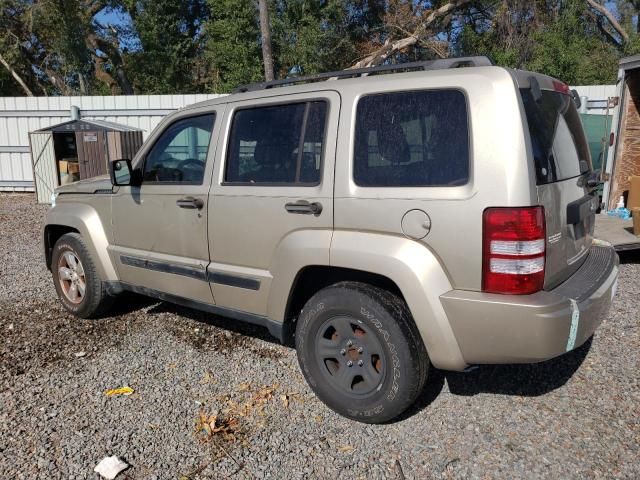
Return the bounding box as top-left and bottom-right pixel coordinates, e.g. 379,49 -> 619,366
354,90 -> 469,187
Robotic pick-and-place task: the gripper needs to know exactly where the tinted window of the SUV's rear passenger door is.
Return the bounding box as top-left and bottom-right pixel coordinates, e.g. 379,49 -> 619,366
225,101 -> 327,185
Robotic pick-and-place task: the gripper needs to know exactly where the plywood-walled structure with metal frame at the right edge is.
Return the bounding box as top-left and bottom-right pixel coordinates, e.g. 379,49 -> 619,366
602,55 -> 640,210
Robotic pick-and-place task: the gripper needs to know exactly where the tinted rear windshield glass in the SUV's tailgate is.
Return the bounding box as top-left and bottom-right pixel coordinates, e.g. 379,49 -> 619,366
521,89 -> 591,185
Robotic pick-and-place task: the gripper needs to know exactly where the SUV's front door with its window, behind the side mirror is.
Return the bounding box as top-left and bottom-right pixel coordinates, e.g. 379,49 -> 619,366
109,107 -> 221,303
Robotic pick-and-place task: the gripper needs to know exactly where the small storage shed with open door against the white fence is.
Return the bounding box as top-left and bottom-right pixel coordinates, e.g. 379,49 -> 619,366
29,119 -> 142,203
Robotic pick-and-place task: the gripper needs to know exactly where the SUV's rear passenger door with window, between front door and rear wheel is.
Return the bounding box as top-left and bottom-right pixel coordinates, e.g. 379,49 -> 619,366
209,91 -> 340,320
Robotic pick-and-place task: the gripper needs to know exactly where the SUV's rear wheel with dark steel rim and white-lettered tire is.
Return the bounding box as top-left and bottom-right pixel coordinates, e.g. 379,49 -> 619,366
295,282 -> 429,423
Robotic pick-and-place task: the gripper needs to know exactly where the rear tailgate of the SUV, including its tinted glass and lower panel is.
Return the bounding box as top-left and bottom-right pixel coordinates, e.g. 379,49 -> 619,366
521,89 -> 597,288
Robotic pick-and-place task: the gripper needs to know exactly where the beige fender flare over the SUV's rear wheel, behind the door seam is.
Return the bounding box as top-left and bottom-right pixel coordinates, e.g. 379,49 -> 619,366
330,230 -> 467,370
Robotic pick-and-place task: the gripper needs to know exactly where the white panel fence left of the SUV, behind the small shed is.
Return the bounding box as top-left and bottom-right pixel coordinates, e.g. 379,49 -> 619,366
0,94 -> 221,192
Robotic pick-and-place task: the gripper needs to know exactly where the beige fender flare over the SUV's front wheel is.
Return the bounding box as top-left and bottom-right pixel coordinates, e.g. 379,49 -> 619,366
45,202 -> 118,281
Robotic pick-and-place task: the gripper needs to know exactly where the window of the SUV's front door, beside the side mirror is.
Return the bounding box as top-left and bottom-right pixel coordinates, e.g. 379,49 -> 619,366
143,114 -> 215,185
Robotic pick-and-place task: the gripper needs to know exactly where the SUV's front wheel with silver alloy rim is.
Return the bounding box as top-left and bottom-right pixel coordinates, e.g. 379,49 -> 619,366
51,233 -> 113,318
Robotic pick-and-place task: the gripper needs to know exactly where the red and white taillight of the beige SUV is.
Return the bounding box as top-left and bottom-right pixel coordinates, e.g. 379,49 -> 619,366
482,207 -> 545,295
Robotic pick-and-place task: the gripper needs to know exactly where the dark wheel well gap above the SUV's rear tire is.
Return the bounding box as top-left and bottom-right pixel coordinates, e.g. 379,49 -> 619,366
283,265 -> 404,343
